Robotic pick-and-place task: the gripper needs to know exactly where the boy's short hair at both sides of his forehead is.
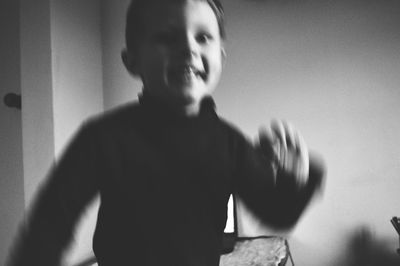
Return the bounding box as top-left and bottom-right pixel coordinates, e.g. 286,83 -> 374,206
125,0 -> 225,51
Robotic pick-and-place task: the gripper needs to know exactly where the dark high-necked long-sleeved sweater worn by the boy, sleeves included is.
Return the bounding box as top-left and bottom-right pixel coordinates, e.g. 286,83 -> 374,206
7,97 -> 320,266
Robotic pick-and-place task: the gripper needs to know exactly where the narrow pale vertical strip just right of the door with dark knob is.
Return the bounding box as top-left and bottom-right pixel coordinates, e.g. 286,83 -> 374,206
20,0 -> 54,206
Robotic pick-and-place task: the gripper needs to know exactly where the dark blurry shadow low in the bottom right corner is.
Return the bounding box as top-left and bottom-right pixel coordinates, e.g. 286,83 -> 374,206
335,227 -> 400,266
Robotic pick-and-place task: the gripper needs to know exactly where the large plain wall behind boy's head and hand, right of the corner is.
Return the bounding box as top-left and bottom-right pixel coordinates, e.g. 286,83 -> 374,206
103,0 -> 400,266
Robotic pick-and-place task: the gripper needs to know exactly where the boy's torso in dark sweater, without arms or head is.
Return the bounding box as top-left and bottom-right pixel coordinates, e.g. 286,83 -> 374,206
86,100 -> 244,266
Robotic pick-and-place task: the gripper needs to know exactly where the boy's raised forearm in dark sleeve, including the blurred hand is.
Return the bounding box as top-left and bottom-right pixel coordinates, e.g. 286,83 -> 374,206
236,122 -> 325,229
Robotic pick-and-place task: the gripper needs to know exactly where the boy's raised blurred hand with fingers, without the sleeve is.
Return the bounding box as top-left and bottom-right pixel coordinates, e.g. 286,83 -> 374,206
259,121 -> 309,188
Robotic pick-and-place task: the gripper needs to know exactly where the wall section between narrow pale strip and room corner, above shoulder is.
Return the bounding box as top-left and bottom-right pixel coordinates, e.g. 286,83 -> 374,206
51,0 -> 103,155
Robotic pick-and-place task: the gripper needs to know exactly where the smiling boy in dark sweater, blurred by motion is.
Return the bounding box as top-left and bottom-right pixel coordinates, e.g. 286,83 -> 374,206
7,0 -> 322,266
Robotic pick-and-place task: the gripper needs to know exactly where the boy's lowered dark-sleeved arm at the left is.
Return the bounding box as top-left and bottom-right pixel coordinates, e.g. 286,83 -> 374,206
7,123 -> 98,266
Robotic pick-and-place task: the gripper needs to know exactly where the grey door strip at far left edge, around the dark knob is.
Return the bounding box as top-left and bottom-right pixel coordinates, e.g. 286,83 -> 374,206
0,0 -> 24,265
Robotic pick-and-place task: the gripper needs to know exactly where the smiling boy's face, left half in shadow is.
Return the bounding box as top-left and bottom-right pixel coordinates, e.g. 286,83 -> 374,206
126,0 -> 225,112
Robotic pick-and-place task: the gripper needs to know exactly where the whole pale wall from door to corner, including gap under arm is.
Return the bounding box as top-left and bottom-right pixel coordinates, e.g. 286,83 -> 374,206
21,0 -> 103,263
